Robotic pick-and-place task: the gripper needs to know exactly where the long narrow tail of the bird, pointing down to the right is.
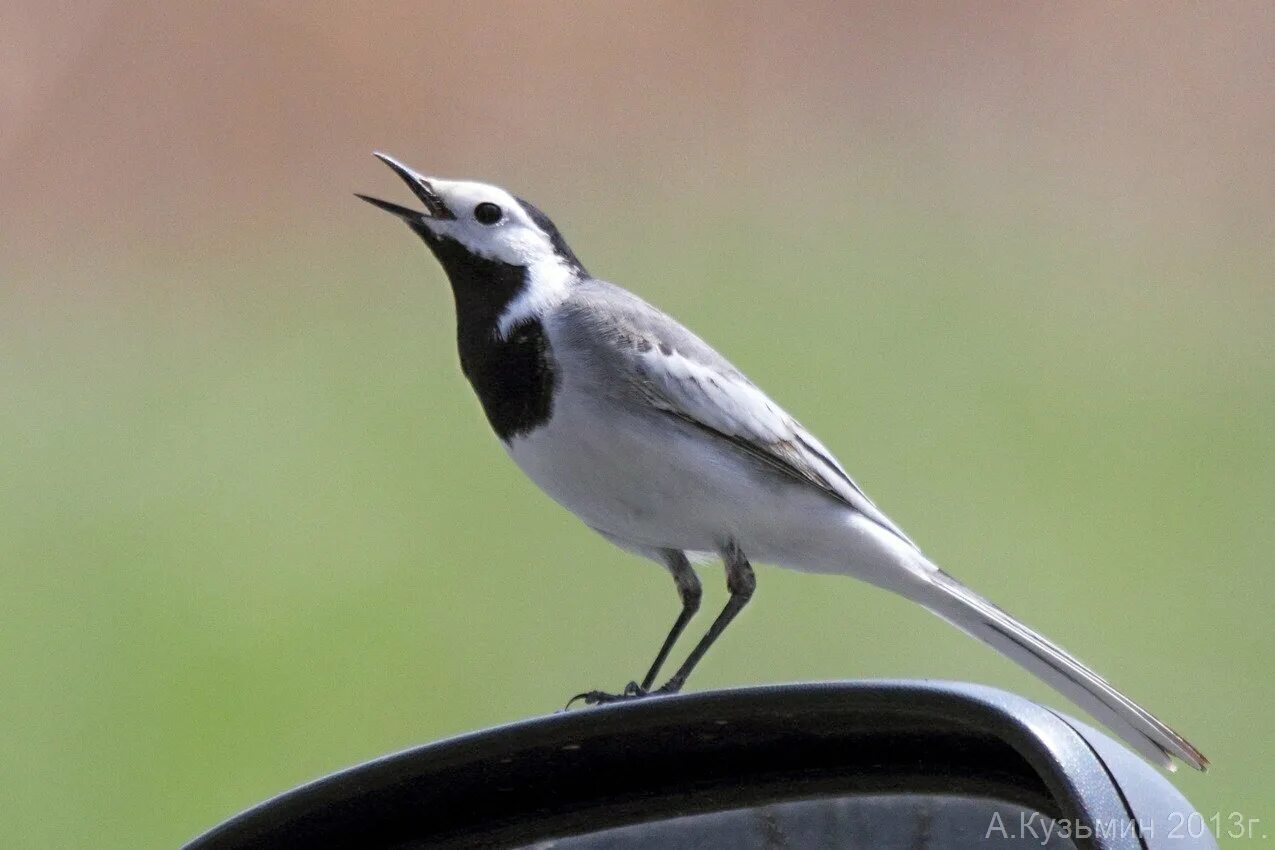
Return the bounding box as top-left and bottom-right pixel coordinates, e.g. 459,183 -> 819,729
909,568 -> 1209,771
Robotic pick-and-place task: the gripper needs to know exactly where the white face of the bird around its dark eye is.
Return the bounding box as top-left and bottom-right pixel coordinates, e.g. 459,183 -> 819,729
422,177 -> 557,268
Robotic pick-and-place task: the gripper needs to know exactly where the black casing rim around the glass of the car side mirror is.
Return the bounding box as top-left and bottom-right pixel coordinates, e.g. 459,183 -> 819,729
187,682 -> 1213,850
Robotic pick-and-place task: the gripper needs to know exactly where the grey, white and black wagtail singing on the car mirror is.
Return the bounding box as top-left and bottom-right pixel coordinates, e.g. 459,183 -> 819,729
357,152 -> 1209,771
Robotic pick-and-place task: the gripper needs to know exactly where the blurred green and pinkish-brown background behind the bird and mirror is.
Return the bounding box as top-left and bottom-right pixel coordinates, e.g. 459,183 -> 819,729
0,0 -> 1275,847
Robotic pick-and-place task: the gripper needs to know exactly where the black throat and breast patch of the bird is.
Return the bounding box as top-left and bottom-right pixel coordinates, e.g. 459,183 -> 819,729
412,227 -> 558,442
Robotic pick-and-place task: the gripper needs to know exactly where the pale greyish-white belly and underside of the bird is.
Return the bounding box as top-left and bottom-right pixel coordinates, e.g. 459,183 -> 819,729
497,389 -> 908,585
